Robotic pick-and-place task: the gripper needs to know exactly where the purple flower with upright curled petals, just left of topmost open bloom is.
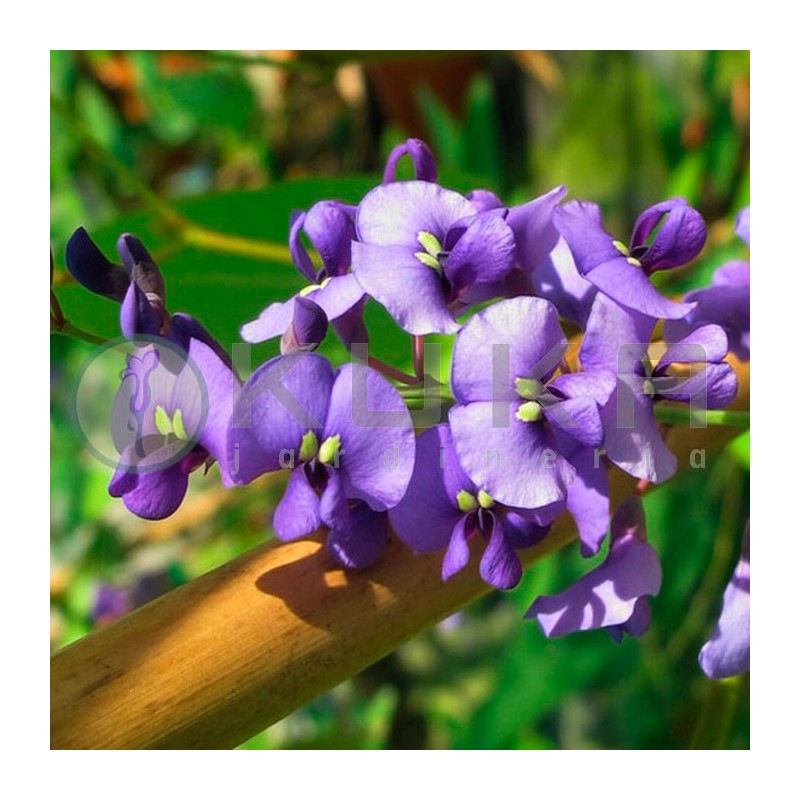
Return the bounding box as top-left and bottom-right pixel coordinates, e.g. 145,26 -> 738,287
241,200 -> 367,353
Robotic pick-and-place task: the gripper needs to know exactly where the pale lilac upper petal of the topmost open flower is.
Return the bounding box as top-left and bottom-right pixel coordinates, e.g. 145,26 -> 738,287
353,181 -> 476,247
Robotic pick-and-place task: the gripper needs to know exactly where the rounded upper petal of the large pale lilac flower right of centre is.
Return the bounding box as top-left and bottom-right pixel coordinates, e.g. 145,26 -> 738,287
452,297 -> 566,403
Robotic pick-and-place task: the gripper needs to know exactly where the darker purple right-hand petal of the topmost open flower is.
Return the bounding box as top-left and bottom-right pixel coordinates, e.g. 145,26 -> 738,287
444,213 -> 514,294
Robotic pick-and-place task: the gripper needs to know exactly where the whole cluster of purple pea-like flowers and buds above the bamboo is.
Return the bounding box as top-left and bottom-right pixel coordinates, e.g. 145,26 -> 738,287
67,139 -> 750,674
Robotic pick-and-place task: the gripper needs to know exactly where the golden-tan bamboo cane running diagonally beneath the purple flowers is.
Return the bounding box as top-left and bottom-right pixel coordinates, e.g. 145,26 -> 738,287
51,362 -> 750,749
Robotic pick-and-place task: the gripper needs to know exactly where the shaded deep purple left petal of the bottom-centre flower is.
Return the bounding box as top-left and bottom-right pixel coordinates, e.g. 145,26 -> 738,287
389,425 -> 462,553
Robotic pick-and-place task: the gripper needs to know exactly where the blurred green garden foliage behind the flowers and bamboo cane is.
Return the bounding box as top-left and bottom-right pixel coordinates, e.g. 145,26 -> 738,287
50,51 -> 750,749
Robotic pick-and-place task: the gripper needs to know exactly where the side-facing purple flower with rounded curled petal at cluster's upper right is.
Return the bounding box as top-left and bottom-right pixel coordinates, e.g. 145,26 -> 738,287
553,198 -> 706,319
